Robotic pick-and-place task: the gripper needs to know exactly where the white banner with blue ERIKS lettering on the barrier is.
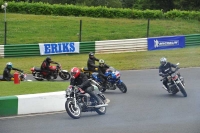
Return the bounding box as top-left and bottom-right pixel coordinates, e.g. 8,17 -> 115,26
39,42 -> 80,55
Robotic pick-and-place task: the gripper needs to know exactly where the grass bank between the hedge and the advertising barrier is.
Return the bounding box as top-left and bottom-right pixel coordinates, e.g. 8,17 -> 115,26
0,13 -> 200,44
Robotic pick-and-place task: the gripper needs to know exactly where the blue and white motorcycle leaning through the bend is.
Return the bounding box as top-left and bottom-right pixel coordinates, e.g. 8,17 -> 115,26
92,67 -> 127,93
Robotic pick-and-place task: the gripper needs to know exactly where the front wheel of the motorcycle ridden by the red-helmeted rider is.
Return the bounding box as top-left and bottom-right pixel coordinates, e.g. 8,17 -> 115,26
65,99 -> 81,119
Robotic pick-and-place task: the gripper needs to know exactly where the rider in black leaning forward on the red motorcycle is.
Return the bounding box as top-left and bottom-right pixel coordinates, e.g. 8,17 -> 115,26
41,56 -> 58,78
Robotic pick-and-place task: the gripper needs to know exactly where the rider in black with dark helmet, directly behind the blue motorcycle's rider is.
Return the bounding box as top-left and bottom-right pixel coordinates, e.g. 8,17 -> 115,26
87,52 -> 99,72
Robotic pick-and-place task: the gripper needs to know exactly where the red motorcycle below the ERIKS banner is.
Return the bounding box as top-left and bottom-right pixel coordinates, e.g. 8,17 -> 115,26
31,64 -> 71,81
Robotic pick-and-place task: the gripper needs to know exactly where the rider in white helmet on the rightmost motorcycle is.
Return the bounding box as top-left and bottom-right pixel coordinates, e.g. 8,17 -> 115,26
159,57 -> 180,92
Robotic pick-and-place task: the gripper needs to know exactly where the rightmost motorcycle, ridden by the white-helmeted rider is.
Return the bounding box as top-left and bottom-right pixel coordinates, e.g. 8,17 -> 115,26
160,63 -> 187,97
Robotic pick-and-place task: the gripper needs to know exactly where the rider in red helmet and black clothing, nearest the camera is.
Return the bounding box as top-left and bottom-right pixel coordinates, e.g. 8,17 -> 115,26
68,67 -> 101,104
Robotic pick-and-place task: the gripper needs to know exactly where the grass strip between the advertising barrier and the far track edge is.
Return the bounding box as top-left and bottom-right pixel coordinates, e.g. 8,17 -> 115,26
0,47 -> 200,74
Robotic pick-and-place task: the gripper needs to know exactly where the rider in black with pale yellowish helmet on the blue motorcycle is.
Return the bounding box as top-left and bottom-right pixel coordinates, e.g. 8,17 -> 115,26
97,59 -> 110,87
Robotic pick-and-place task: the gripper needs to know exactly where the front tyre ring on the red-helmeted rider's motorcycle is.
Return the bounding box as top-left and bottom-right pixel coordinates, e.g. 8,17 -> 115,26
65,99 -> 81,119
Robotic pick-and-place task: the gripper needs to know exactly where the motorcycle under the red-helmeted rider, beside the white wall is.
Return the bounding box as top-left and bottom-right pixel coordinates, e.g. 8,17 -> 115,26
65,85 -> 108,119
